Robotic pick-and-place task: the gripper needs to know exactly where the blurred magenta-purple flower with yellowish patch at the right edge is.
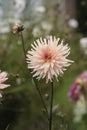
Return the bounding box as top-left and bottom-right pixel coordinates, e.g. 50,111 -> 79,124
68,71 -> 87,101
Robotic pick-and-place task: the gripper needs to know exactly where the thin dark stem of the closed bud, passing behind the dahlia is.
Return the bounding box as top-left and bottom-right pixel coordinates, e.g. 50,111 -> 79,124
20,32 -> 48,113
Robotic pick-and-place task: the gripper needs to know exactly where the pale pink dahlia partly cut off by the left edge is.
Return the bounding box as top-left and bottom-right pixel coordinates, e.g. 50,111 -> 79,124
0,72 -> 10,89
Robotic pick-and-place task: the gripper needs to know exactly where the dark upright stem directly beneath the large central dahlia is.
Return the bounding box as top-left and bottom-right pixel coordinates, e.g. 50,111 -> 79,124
49,81 -> 53,130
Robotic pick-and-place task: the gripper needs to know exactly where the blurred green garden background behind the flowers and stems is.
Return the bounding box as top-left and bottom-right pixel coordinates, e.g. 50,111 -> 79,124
0,0 -> 87,130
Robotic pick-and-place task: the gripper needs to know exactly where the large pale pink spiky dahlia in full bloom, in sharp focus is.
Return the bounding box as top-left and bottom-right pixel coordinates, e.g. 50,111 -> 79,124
26,36 -> 73,82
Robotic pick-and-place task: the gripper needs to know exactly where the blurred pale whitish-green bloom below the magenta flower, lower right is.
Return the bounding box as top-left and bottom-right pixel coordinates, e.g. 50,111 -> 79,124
74,96 -> 87,122
